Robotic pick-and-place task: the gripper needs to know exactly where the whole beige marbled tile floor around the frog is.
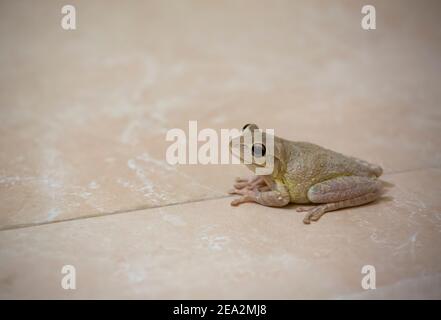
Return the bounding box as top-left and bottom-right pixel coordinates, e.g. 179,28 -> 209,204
0,0 -> 441,299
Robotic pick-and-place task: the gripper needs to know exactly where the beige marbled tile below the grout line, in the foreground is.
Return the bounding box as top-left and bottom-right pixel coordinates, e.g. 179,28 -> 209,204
0,169 -> 441,299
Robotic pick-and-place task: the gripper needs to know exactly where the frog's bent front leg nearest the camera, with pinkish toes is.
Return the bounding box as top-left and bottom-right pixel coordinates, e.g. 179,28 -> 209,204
230,180 -> 290,207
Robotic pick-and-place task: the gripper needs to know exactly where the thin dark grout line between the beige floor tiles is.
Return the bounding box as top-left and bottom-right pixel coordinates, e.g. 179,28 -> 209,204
0,167 -> 441,232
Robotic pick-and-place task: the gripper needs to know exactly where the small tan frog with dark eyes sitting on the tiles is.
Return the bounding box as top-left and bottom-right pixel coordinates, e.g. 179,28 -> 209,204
229,124 -> 383,224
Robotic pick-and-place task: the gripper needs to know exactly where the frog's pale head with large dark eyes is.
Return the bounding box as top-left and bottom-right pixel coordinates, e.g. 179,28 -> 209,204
230,124 -> 285,176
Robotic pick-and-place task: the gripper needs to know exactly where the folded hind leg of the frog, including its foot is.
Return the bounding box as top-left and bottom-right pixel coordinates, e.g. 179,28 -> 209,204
297,176 -> 382,224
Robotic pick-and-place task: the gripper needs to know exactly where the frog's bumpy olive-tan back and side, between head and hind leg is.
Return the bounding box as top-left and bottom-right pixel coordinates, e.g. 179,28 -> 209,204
283,140 -> 382,203
